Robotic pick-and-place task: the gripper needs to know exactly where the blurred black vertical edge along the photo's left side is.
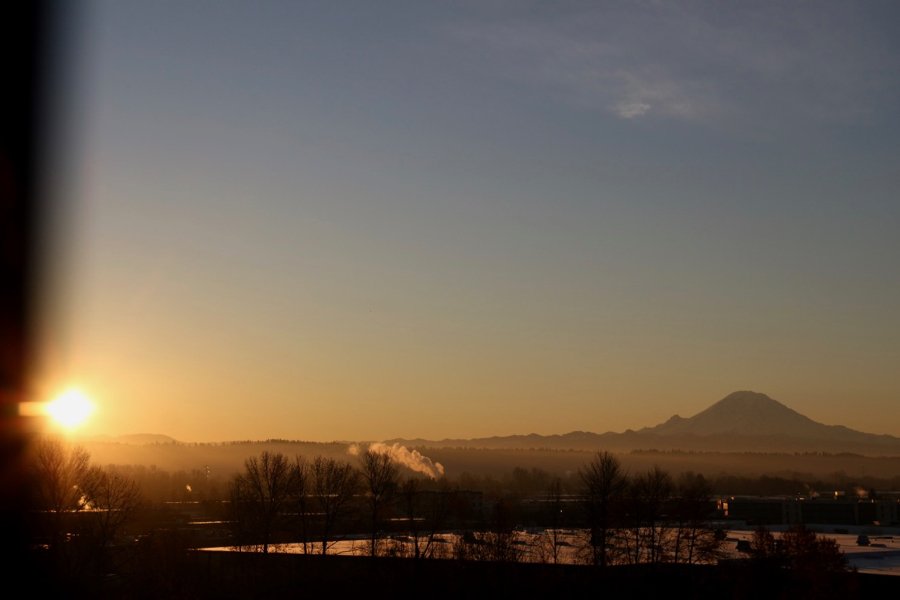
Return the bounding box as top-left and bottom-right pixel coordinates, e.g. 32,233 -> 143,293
0,1 -> 56,590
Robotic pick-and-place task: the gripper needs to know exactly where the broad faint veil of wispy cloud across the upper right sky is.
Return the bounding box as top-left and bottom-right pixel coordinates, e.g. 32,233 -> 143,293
454,2 -> 900,125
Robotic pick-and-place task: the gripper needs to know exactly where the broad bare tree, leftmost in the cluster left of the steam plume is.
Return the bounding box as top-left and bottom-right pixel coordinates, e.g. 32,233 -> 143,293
231,451 -> 296,553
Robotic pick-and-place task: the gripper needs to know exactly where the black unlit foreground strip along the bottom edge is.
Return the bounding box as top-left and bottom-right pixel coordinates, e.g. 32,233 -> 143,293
30,538 -> 900,600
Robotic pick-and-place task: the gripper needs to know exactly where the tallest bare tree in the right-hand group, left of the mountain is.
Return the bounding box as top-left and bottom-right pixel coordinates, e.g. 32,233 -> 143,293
578,452 -> 628,566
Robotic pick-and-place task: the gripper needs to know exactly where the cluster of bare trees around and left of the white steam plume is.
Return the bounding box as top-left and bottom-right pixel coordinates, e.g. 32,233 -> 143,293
228,450 -> 465,557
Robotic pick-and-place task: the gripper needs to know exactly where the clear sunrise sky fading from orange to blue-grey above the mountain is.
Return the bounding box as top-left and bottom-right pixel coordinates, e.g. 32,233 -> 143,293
34,0 -> 900,441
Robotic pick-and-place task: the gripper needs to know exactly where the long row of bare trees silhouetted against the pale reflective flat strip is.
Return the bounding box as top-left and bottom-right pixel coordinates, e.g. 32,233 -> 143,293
221,450 -> 724,566
